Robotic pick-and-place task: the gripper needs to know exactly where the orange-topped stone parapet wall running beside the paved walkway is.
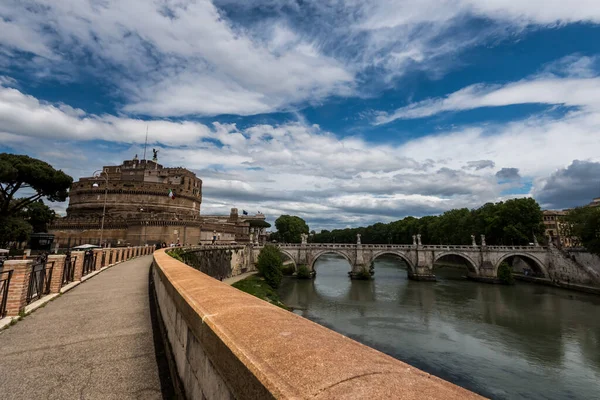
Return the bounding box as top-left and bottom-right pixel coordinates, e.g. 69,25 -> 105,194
152,249 -> 480,400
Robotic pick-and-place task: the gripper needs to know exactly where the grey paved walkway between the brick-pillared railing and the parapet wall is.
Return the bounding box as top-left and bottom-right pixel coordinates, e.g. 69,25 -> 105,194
0,256 -> 172,399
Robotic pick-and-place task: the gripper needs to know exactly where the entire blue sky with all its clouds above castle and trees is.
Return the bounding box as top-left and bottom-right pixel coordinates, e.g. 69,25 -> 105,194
0,0 -> 600,230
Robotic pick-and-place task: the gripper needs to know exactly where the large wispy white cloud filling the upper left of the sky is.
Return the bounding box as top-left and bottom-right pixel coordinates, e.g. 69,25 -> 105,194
0,0 -> 353,116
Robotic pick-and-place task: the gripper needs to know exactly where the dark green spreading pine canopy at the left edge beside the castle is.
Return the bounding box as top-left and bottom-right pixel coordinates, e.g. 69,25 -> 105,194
0,153 -> 73,217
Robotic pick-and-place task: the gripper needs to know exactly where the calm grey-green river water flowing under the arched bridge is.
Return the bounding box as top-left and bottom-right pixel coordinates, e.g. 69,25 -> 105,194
280,254 -> 600,399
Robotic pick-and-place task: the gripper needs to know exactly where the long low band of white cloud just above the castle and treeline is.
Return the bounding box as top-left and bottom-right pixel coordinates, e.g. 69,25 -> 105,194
0,80 -> 600,228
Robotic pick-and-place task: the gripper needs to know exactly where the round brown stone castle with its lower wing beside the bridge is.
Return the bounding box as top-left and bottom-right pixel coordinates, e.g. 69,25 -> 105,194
50,156 -> 265,248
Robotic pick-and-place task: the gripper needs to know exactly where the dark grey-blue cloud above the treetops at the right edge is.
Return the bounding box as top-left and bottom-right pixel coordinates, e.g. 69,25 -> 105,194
534,160 -> 600,209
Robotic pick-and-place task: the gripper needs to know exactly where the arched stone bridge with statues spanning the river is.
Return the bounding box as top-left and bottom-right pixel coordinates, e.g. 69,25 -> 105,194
270,243 -> 552,281
